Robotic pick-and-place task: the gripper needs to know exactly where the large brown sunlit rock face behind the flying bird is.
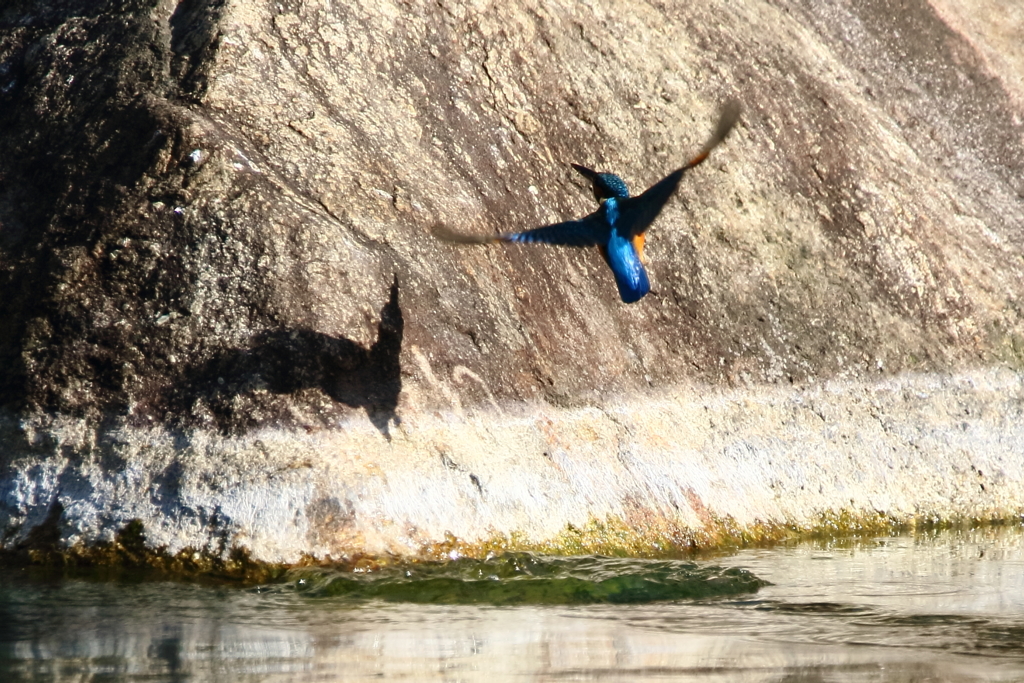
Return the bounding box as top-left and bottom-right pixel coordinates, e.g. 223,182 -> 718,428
0,0 -> 1024,561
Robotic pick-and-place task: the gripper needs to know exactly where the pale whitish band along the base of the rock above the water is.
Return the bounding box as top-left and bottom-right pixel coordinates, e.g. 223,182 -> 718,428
0,371 -> 1024,571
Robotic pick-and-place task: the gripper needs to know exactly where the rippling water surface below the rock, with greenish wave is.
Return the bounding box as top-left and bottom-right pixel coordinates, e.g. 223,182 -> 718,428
0,527 -> 1024,683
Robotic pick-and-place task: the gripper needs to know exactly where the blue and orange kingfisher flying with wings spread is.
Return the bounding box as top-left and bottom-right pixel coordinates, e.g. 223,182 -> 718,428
433,101 -> 740,303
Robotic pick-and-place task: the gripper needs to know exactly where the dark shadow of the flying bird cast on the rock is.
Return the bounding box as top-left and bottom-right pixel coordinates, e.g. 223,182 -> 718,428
161,278 -> 404,439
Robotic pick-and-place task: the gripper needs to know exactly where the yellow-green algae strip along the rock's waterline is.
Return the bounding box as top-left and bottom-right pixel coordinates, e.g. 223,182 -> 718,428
0,510 -> 1024,590
